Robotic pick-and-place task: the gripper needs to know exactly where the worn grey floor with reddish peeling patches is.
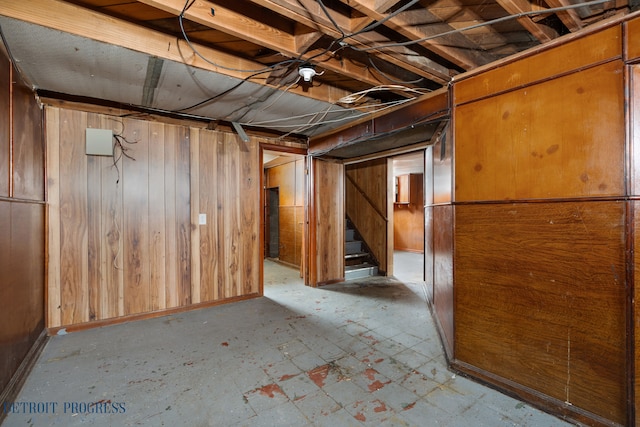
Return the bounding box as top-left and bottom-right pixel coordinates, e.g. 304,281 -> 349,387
3,259 -> 568,427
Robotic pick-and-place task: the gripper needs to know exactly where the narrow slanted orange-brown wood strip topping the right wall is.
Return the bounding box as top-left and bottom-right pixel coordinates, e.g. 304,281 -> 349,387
453,25 -> 622,105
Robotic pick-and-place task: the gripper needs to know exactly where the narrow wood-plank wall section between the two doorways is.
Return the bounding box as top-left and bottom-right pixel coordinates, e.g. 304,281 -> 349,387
310,159 -> 345,285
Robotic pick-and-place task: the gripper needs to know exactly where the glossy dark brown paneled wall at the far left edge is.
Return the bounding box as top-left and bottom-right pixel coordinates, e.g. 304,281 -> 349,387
0,43 -> 46,412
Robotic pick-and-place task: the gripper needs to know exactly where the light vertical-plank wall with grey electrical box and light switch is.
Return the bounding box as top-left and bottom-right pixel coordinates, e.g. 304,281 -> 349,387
46,107 -> 261,327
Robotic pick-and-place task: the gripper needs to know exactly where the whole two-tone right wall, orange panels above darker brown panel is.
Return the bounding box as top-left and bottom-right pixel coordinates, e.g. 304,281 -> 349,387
453,20 -> 633,425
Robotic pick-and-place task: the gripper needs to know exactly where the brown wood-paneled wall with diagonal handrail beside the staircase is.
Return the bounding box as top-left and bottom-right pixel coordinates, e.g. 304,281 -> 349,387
345,159 -> 393,272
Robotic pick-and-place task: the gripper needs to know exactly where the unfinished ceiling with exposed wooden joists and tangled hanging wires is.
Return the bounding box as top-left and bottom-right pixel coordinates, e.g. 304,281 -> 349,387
0,0 -> 637,144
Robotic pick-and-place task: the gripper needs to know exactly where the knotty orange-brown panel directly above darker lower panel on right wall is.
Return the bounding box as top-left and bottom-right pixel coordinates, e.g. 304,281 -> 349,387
454,60 -> 625,202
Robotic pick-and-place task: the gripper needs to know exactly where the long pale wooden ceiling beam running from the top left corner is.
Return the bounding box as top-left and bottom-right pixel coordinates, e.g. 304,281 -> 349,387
0,0 -> 351,103
